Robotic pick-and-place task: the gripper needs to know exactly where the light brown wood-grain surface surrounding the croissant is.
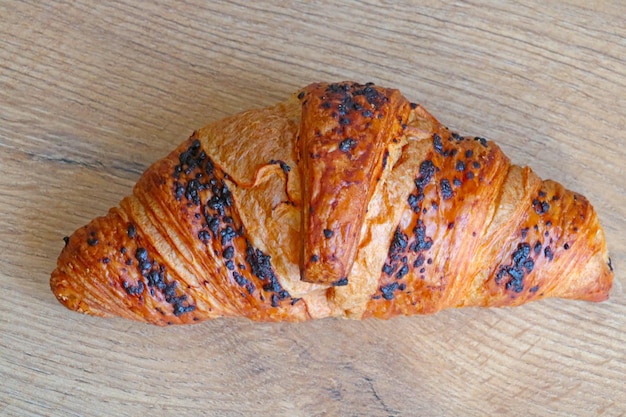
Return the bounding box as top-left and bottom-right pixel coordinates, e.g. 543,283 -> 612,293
0,0 -> 626,416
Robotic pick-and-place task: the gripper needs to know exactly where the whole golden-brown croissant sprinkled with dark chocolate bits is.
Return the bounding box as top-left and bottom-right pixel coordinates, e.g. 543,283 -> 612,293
50,82 -> 613,325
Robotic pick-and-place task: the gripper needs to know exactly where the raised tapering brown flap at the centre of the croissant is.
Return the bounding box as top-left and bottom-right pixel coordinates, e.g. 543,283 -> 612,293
299,82 -> 410,285
